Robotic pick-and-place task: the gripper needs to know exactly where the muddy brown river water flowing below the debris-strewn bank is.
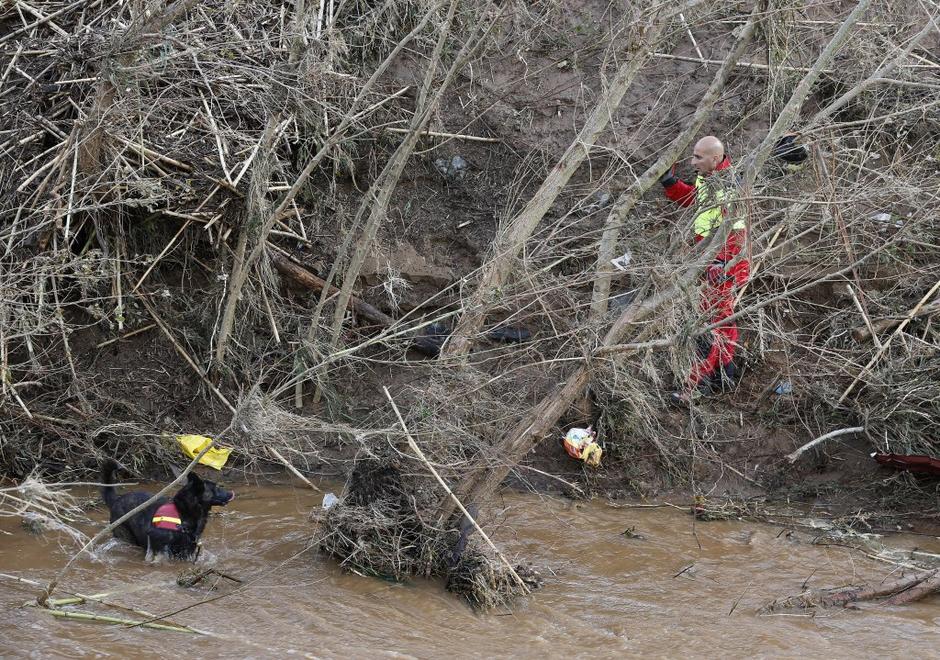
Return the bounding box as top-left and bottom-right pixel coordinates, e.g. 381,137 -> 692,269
0,487 -> 940,658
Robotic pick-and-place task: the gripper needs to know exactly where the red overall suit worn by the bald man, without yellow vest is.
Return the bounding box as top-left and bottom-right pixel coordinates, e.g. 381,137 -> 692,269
665,157 -> 750,390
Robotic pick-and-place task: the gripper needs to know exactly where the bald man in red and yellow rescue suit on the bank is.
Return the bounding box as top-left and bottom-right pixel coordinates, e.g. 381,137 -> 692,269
660,135 -> 750,404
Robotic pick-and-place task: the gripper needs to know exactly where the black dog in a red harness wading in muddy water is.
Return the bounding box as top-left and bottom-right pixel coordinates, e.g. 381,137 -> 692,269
101,459 -> 235,559
